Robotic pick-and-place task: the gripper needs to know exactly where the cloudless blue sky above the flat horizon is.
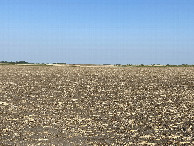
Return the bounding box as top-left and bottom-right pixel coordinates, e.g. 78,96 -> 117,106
0,0 -> 194,64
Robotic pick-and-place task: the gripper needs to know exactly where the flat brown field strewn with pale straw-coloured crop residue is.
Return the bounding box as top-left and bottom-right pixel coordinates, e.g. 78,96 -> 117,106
0,65 -> 194,146
